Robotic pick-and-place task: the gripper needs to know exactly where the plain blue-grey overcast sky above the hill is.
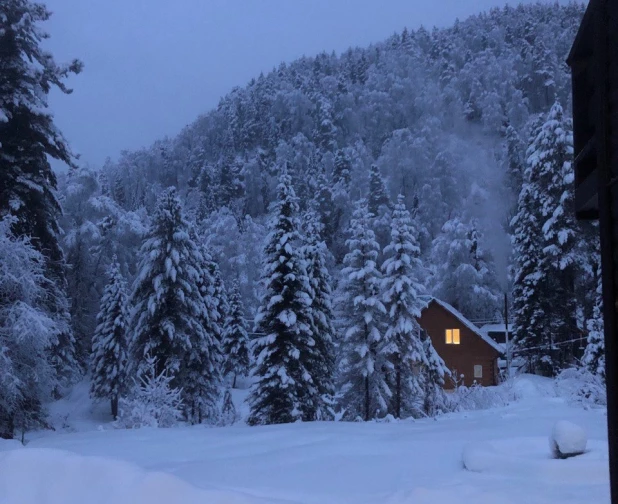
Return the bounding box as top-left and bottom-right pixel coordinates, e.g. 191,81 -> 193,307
46,0 -> 572,170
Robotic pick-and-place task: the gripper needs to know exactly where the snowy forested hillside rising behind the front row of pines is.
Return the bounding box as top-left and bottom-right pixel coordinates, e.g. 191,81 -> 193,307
63,4 -> 583,318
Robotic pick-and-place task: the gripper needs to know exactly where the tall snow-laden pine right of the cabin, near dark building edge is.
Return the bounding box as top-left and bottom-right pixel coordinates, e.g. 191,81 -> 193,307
512,103 -> 578,376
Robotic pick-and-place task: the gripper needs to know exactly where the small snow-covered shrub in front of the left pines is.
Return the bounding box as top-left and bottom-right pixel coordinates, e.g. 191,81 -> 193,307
116,356 -> 182,429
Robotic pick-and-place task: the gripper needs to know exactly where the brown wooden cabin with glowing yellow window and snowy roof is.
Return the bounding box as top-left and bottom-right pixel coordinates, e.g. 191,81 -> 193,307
419,297 -> 502,388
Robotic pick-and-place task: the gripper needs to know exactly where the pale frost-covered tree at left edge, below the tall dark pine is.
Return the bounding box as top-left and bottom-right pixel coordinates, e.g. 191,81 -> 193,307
0,216 -> 57,439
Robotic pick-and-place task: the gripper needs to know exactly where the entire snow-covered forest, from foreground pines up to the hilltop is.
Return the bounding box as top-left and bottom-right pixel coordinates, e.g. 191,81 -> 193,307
0,0 -> 604,438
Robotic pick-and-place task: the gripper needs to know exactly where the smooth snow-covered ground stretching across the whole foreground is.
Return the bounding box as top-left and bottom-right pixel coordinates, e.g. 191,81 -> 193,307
0,377 -> 609,504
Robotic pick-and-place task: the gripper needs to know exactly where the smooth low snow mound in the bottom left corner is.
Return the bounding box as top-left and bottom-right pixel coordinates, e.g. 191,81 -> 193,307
0,448 -> 249,504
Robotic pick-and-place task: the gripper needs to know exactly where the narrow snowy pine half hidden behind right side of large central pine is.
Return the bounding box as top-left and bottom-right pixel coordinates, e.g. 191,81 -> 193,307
302,211 -> 335,420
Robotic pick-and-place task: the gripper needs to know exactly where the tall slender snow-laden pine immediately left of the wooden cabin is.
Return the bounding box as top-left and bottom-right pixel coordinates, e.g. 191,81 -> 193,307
382,194 -> 427,418
